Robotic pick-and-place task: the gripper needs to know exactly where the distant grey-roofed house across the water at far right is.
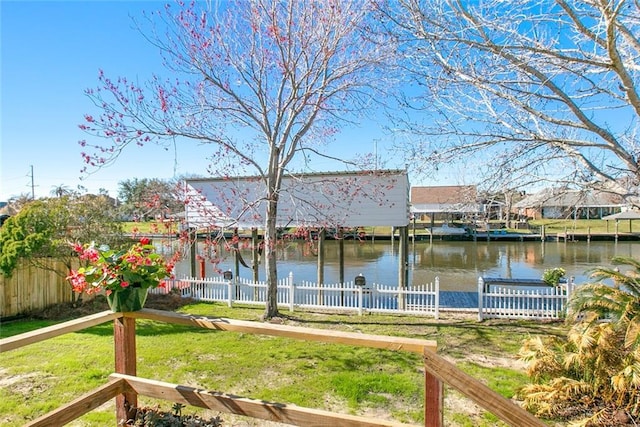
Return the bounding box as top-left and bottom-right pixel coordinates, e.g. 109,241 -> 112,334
514,188 -> 626,219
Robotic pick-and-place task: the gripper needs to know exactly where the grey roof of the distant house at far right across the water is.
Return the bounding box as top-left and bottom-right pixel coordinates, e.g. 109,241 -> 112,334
514,188 -> 624,208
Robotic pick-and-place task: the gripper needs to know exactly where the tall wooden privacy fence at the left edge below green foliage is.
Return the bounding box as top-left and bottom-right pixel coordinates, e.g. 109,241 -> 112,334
0,258 -> 73,318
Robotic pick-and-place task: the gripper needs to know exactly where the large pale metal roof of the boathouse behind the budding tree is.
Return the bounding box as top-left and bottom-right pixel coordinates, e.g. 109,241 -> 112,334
185,170 -> 409,231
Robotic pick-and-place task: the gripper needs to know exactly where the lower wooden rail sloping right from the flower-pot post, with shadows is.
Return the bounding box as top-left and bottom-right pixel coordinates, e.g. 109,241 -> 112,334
110,374 -> 408,427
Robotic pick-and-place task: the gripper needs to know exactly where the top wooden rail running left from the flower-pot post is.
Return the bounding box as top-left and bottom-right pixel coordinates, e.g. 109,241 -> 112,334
0,310 -> 122,353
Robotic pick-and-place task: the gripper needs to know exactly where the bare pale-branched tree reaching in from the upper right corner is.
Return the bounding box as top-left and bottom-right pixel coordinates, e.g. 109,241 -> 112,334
385,0 -> 640,204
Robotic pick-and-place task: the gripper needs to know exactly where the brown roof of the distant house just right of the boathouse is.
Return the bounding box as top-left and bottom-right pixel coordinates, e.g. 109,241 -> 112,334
411,185 -> 481,213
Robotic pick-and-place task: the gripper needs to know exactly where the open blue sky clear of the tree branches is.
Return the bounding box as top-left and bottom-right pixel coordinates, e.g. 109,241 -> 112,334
0,0 -> 456,201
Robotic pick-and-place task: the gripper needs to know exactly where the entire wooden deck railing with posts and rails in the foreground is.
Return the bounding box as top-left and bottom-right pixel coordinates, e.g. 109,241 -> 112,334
0,309 -> 544,427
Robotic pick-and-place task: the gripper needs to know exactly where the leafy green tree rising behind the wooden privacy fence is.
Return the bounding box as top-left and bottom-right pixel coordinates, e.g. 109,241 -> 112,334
0,195 -> 126,300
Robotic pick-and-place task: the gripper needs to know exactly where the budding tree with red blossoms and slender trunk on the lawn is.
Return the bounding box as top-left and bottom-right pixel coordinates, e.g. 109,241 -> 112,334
81,0 -> 392,318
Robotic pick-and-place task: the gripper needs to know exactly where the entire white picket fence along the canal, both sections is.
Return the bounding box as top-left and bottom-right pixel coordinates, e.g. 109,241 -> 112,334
152,273 -> 575,320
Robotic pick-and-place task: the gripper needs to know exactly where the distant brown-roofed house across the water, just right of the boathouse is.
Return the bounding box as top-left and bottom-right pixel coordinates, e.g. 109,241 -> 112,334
411,185 -> 484,221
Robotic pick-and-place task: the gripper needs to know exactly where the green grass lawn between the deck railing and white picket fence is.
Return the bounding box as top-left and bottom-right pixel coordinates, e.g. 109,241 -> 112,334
0,303 -> 563,426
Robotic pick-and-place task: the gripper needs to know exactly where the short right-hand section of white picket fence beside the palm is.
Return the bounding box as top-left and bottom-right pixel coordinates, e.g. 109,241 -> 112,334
478,277 -> 575,320
